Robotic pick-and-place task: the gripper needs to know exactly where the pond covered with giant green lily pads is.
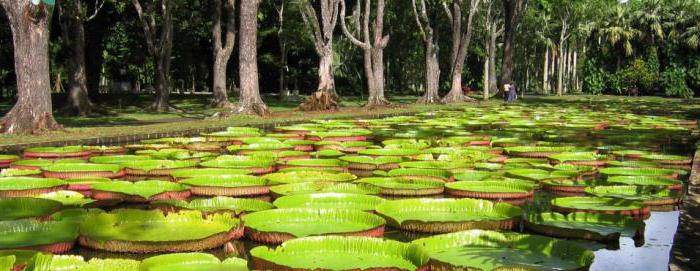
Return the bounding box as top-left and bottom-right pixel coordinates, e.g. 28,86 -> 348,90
0,105 -> 697,271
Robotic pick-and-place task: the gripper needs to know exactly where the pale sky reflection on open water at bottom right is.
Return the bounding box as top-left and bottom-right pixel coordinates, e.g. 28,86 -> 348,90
591,211 -> 680,271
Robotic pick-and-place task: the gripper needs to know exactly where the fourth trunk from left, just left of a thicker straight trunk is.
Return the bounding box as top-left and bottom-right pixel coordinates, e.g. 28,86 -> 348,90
212,0 -> 236,109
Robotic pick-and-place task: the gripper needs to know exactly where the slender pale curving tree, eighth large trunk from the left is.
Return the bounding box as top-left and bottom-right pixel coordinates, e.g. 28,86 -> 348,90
411,0 -> 440,104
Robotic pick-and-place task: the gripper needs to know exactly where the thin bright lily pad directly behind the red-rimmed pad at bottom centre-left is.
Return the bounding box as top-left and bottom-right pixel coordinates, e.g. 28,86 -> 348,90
274,193 -> 384,211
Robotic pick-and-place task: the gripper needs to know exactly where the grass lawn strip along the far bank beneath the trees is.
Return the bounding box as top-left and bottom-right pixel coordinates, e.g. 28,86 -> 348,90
0,95 -> 700,151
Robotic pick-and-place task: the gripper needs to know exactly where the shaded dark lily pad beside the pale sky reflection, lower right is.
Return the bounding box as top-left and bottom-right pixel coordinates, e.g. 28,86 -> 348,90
525,212 -> 644,241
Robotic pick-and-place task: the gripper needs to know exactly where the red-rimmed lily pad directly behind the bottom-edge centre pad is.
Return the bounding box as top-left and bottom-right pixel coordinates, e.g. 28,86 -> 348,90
243,208 -> 386,244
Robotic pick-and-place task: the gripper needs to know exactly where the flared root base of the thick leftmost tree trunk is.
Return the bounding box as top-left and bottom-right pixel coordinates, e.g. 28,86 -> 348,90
0,111 -> 63,134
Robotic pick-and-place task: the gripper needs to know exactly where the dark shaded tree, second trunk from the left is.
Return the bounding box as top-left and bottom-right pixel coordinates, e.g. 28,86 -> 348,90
58,0 -> 106,116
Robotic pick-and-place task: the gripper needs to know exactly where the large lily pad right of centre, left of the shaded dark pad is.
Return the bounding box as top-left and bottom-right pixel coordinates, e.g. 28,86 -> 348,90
376,199 -> 522,233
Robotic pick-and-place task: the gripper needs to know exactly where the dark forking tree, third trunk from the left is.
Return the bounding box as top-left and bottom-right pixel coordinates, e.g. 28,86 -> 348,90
131,0 -> 176,112
